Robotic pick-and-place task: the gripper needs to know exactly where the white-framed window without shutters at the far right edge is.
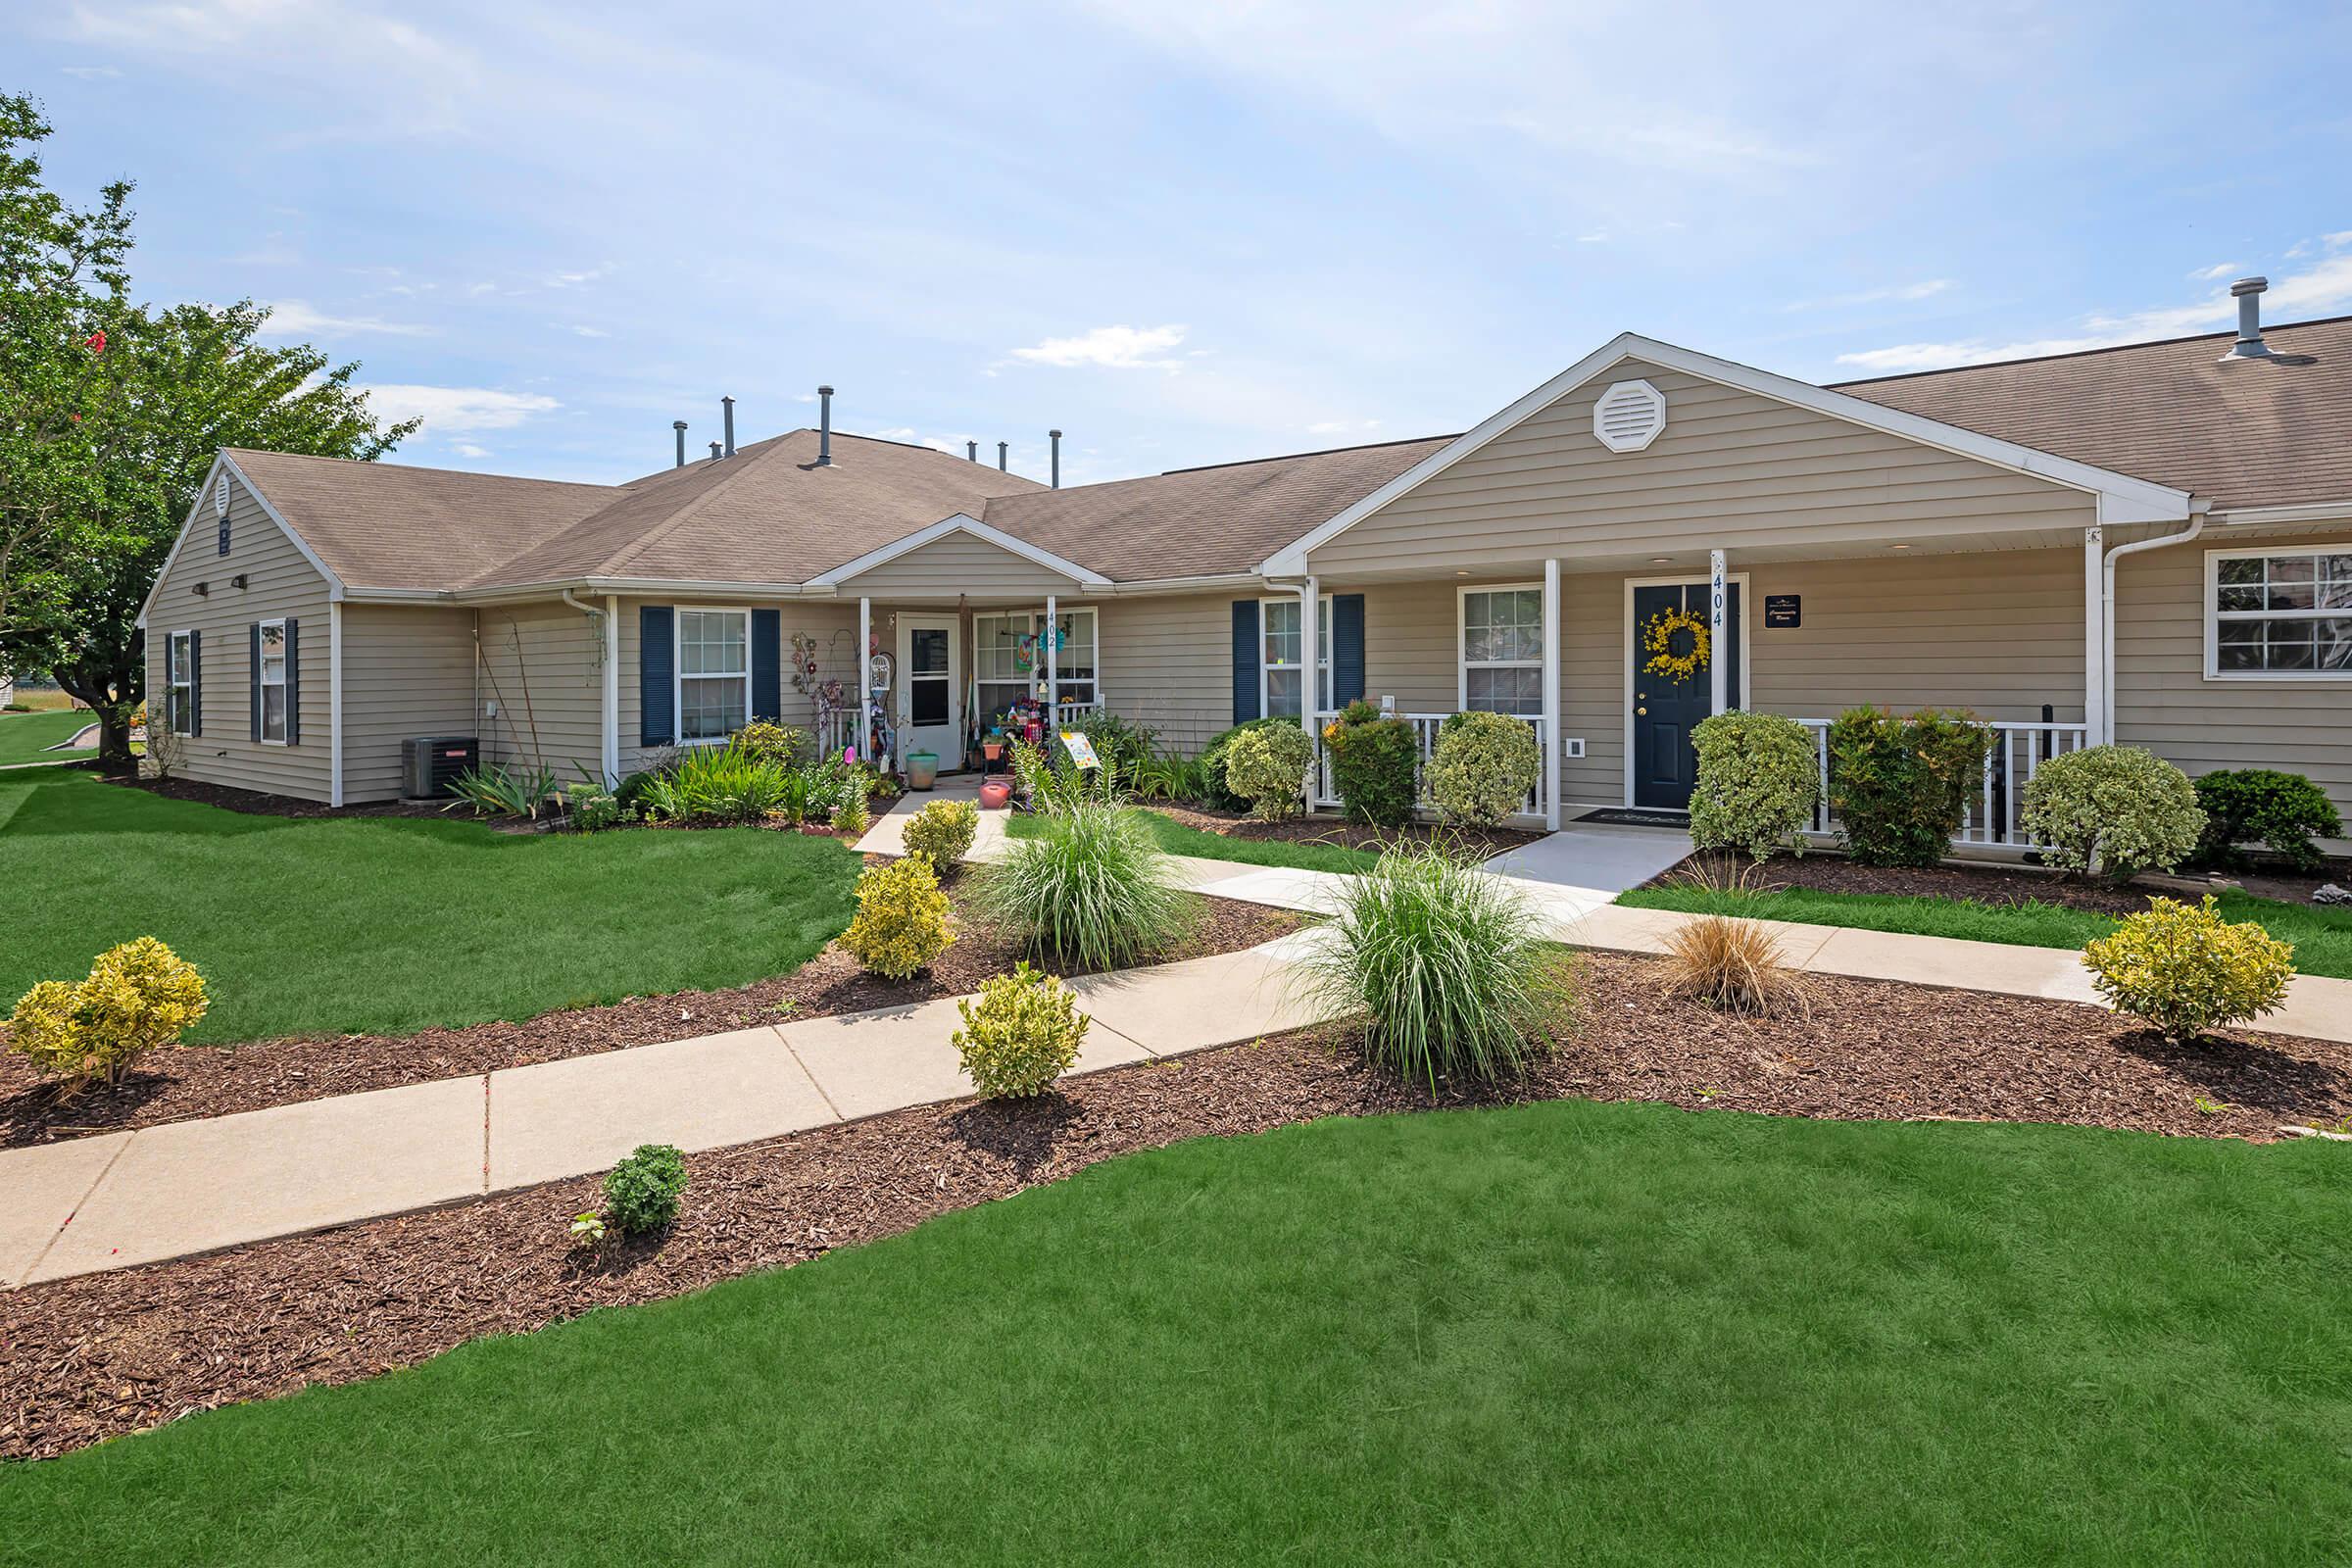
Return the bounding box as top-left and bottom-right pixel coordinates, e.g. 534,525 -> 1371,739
2206,546 -> 2352,679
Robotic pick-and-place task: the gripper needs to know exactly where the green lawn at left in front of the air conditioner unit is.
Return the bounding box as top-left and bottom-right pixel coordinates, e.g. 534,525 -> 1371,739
0,770 -> 860,1042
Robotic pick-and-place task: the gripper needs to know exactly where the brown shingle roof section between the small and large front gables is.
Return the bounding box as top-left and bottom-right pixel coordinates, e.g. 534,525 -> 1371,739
983,435 -> 1453,583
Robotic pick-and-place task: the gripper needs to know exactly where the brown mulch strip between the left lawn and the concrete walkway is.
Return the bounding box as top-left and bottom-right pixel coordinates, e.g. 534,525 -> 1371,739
0,884 -> 1300,1148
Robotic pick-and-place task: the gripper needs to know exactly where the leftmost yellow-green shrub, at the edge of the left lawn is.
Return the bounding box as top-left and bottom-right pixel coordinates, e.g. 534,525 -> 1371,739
10,936 -> 210,1084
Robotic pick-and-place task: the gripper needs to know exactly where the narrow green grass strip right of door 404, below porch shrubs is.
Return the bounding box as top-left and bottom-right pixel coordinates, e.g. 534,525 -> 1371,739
1618,889 -> 2352,980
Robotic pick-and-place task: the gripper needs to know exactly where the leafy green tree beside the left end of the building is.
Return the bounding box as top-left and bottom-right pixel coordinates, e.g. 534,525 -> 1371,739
0,96 -> 418,766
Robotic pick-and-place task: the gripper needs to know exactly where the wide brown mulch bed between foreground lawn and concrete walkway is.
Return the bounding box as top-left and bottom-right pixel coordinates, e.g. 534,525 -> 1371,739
0,956 -> 2352,1457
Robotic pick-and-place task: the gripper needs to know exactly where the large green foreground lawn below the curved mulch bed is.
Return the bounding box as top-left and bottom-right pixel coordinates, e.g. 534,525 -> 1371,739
0,1102 -> 2352,1568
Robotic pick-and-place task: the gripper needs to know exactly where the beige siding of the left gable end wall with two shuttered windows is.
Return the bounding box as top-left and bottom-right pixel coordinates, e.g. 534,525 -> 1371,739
146,484 -> 334,802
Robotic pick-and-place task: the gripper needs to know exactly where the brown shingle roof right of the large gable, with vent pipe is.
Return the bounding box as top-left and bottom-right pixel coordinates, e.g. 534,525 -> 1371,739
1833,318 -> 2352,511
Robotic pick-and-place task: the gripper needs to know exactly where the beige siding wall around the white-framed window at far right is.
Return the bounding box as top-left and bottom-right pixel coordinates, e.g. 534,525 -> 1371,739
2115,524 -> 2352,820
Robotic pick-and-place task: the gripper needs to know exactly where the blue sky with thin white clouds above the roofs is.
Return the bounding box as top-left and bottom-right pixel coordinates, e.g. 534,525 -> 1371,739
14,0 -> 2352,482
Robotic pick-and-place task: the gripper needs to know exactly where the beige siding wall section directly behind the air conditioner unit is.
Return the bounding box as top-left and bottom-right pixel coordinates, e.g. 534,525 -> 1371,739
343,604 -> 480,804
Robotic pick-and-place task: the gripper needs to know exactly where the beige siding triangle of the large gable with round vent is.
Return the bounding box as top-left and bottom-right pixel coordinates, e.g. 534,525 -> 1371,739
1307,362 -> 2095,576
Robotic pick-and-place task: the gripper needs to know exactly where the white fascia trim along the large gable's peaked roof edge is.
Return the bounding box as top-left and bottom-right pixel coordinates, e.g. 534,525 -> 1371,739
1258,331 -> 2189,576
